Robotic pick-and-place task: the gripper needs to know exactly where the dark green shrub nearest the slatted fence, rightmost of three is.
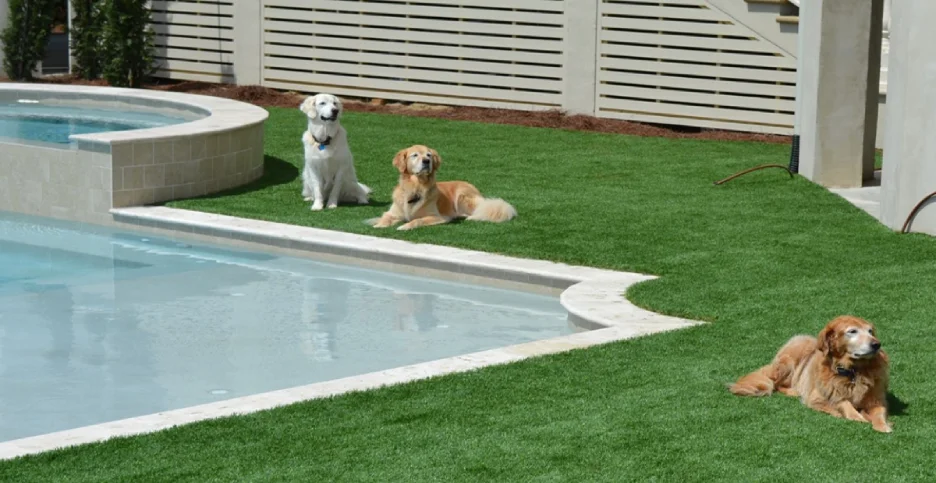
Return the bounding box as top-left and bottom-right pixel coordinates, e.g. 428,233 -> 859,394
103,0 -> 154,87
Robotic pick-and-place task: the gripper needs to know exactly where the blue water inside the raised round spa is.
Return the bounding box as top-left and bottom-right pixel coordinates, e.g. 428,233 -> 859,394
0,103 -> 186,144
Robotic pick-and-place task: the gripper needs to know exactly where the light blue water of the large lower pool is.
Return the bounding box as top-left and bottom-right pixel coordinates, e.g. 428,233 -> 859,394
0,212 -> 572,441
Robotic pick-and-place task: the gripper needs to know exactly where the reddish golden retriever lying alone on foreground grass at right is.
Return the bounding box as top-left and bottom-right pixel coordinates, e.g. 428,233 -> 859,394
730,315 -> 891,433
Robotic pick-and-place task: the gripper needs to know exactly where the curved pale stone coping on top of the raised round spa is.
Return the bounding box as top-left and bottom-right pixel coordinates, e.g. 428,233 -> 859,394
0,83 -> 269,145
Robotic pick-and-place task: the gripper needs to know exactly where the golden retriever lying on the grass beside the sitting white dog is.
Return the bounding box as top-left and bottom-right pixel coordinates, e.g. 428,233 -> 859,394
367,145 -> 517,230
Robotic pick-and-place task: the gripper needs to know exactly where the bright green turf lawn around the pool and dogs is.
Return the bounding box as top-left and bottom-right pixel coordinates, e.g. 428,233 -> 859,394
0,109 -> 936,482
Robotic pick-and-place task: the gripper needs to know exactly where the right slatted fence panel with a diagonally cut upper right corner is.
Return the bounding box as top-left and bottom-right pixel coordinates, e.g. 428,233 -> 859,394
596,0 -> 796,134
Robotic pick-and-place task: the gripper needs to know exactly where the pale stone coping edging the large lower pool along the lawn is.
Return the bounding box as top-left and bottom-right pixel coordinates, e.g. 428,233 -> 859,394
0,207 -> 702,459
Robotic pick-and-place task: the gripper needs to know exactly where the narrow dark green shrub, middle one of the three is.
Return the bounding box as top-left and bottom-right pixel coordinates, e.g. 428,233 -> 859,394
71,0 -> 104,80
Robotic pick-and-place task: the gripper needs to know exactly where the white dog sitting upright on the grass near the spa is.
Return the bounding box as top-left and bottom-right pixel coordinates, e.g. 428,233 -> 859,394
299,94 -> 371,211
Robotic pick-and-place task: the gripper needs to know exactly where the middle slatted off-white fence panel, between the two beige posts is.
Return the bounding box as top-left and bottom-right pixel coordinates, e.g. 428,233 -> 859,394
262,0 -> 568,109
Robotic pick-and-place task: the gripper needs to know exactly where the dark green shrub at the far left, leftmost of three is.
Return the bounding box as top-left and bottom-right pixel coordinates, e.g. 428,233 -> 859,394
0,0 -> 55,81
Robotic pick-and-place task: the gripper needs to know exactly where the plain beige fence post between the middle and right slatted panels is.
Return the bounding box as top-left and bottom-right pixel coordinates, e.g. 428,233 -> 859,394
562,0 -> 601,116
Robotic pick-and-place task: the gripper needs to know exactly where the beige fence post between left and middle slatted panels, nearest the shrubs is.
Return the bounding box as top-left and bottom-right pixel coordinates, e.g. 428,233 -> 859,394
232,0 -> 264,86
